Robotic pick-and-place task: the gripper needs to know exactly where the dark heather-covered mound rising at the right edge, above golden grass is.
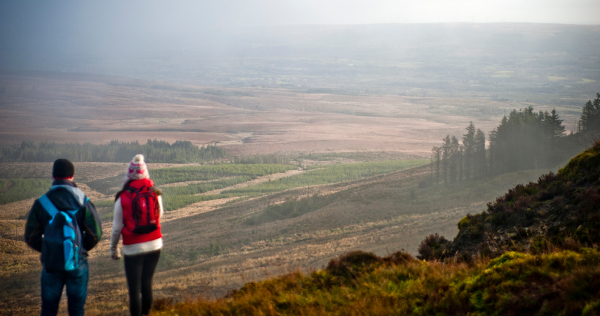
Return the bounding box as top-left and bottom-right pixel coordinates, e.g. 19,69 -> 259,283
421,141 -> 600,260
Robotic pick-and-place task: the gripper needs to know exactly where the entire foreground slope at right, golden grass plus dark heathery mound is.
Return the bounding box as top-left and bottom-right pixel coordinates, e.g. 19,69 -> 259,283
151,146 -> 600,315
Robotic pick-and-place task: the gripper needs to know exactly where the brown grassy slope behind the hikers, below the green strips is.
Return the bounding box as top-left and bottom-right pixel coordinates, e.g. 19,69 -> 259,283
0,162 -> 564,315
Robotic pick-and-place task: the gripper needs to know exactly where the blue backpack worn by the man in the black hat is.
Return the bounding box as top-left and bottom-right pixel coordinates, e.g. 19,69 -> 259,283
38,194 -> 88,272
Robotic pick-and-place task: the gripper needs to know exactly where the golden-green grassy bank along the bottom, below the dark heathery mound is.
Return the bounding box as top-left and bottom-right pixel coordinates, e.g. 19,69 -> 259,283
155,248 -> 600,316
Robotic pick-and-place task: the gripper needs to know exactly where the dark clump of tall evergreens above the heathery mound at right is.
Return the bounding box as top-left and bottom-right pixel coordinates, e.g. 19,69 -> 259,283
431,93 -> 600,183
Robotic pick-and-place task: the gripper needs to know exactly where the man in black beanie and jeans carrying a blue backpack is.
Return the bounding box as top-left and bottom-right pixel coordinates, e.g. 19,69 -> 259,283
25,159 -> 102,316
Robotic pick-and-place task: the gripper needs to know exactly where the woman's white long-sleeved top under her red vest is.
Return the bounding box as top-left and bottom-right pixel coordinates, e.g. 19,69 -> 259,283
110,195 -> 164,256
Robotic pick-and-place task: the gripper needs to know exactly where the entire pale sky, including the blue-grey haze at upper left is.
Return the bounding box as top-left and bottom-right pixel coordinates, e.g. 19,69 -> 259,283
0,0 -> 600,68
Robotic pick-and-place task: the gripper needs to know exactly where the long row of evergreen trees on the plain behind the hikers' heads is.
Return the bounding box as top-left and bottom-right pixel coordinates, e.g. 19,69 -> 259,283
0,139 -> 226,163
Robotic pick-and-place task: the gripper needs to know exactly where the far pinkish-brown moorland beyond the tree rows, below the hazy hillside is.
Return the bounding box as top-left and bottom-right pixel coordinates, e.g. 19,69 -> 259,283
0,73 -> 588,158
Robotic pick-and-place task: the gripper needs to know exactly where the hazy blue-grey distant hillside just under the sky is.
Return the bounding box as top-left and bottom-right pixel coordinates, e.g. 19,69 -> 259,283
5,23 -> 600,98
